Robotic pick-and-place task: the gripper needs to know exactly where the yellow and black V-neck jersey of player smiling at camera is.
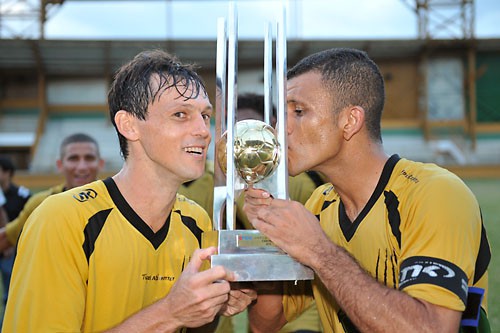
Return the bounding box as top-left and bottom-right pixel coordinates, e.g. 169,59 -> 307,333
3,178 -> 212,332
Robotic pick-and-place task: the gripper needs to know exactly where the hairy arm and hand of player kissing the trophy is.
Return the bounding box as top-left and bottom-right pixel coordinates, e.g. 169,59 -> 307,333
245,189 -> 461,332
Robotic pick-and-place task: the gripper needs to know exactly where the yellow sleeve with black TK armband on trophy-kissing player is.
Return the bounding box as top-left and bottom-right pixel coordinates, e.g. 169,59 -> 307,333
399,174 -> 481,311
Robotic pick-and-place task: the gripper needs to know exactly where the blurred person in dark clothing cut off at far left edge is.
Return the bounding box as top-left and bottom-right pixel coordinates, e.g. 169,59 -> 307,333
0,156 -> 31,318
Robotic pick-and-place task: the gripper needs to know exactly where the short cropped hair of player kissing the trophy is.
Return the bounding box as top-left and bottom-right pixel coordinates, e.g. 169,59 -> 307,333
287,48 -> 385,142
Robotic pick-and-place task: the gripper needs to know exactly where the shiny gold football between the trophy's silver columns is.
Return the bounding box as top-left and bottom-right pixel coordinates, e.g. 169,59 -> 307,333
216,119 -> 280,184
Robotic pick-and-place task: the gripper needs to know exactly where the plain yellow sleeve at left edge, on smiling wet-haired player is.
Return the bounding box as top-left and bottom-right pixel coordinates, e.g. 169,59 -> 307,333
3,191 -> 88,332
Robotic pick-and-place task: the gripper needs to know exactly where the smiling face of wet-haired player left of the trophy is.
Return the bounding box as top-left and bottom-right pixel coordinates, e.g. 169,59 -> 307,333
131,80 -> 212,183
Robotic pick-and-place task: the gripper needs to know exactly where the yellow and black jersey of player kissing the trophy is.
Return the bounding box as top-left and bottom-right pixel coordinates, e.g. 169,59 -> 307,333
283,155 -> 491,332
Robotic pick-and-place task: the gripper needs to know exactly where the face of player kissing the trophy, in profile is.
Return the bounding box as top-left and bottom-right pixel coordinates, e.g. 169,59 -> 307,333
287,71 -> 343,176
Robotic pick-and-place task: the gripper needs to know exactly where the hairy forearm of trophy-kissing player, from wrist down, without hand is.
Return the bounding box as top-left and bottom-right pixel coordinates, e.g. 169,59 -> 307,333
313,242 -> 460,332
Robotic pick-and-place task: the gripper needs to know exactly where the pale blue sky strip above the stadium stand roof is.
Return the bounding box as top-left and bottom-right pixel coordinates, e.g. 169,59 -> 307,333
2,0 -> 500,40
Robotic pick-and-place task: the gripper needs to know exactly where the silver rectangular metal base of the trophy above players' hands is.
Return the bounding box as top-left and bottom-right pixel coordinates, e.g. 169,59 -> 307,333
204,230 -> 314,281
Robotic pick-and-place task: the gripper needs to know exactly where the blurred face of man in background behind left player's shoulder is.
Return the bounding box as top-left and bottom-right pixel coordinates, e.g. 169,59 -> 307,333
57,142 -> 104,189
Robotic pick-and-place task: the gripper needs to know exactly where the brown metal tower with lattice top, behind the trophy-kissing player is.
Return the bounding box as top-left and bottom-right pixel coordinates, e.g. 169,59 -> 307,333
402,0 -> 477,150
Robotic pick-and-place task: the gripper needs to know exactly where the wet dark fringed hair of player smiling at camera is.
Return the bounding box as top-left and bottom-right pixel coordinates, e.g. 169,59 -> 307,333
108,50 -> 208,159
